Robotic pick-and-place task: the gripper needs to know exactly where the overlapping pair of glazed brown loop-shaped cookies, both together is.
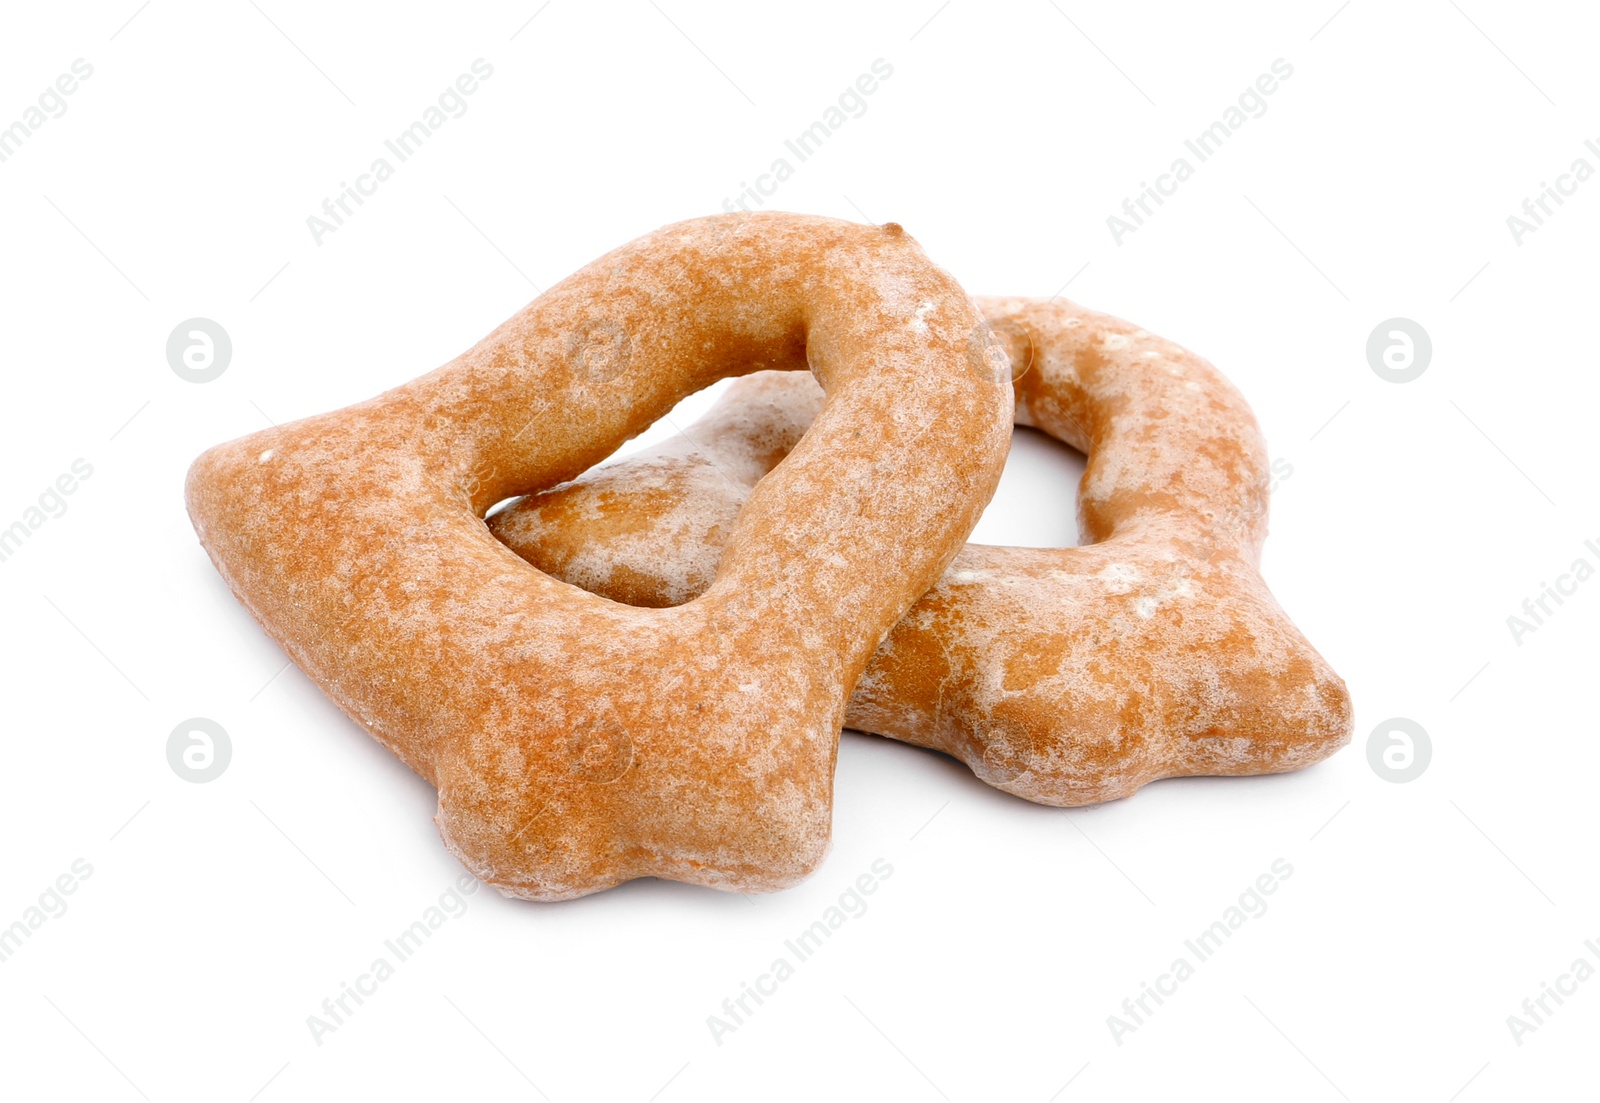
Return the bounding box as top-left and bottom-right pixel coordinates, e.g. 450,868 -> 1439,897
187,213 -> 1350,900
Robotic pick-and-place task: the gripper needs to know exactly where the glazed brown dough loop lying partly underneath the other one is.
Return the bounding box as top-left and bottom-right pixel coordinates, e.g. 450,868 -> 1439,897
490,299 -> 1352,805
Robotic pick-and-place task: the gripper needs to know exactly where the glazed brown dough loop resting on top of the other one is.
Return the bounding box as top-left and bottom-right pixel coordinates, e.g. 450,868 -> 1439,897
187,213 -> 1013,900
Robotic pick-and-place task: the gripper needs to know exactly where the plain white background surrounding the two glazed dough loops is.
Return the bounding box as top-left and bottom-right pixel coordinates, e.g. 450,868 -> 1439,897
0,0 -> 1600,1103
